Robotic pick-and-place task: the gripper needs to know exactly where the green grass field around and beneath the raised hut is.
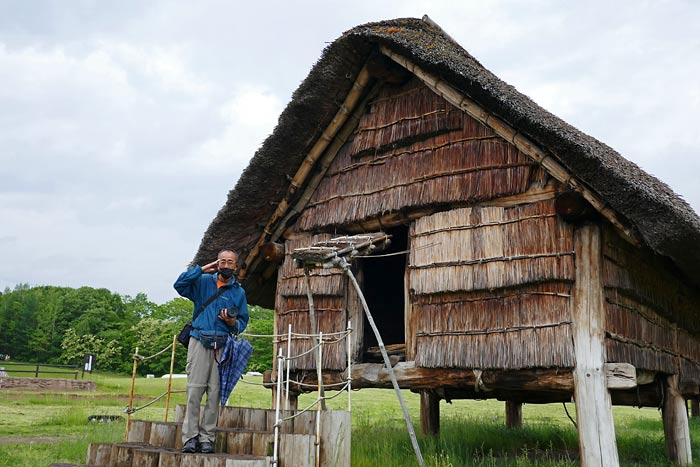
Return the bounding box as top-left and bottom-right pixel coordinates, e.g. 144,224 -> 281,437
0,373 -> 700,467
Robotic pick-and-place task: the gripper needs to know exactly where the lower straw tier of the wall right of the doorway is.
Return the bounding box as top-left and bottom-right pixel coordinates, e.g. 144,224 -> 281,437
412,282 -> 574,369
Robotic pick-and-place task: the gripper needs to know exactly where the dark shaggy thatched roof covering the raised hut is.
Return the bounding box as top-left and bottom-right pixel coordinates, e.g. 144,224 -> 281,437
193,19 -> 700,305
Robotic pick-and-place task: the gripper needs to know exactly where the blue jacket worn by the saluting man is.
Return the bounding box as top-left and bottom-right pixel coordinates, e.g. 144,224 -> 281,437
174,266 -> 248,339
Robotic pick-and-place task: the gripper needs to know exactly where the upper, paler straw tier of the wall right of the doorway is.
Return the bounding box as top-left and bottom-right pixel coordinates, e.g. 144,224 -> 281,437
409,200 -> 574,294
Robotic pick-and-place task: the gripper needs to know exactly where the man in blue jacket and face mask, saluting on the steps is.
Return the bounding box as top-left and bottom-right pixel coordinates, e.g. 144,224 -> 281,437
175,250 -> 248,453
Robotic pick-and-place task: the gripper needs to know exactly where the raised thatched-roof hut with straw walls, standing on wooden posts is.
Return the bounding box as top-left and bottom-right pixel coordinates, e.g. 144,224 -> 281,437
194,18 -> 700,465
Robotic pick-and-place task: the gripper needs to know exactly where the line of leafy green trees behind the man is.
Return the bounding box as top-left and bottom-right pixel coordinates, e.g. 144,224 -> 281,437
0,284 -> 273,375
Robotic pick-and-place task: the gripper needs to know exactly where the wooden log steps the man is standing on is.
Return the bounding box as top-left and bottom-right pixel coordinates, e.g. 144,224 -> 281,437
86,406 -> 350,467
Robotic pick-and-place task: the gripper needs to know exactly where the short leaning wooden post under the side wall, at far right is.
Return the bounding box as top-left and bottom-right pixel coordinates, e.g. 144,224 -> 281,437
661,375 -> 693,465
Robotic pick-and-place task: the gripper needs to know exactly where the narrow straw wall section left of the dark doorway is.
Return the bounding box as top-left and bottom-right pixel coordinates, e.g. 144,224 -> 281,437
275,234 -> 347,370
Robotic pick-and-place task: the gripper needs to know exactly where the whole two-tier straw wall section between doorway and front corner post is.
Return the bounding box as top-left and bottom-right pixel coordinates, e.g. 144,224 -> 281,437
409,200 -> 574,369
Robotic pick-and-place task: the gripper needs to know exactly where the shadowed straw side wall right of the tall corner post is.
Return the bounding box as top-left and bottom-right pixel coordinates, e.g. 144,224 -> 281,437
603,228 -> 700,386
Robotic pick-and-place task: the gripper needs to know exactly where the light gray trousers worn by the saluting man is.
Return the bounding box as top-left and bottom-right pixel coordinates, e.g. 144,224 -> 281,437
182,337 -> 223,444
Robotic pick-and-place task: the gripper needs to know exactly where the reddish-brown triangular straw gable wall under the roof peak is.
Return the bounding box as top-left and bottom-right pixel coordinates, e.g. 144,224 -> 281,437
297,80 -> 545,234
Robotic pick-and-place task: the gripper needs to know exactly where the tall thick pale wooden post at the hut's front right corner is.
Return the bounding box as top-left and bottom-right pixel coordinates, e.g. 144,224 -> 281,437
572,225 -> 620,467
